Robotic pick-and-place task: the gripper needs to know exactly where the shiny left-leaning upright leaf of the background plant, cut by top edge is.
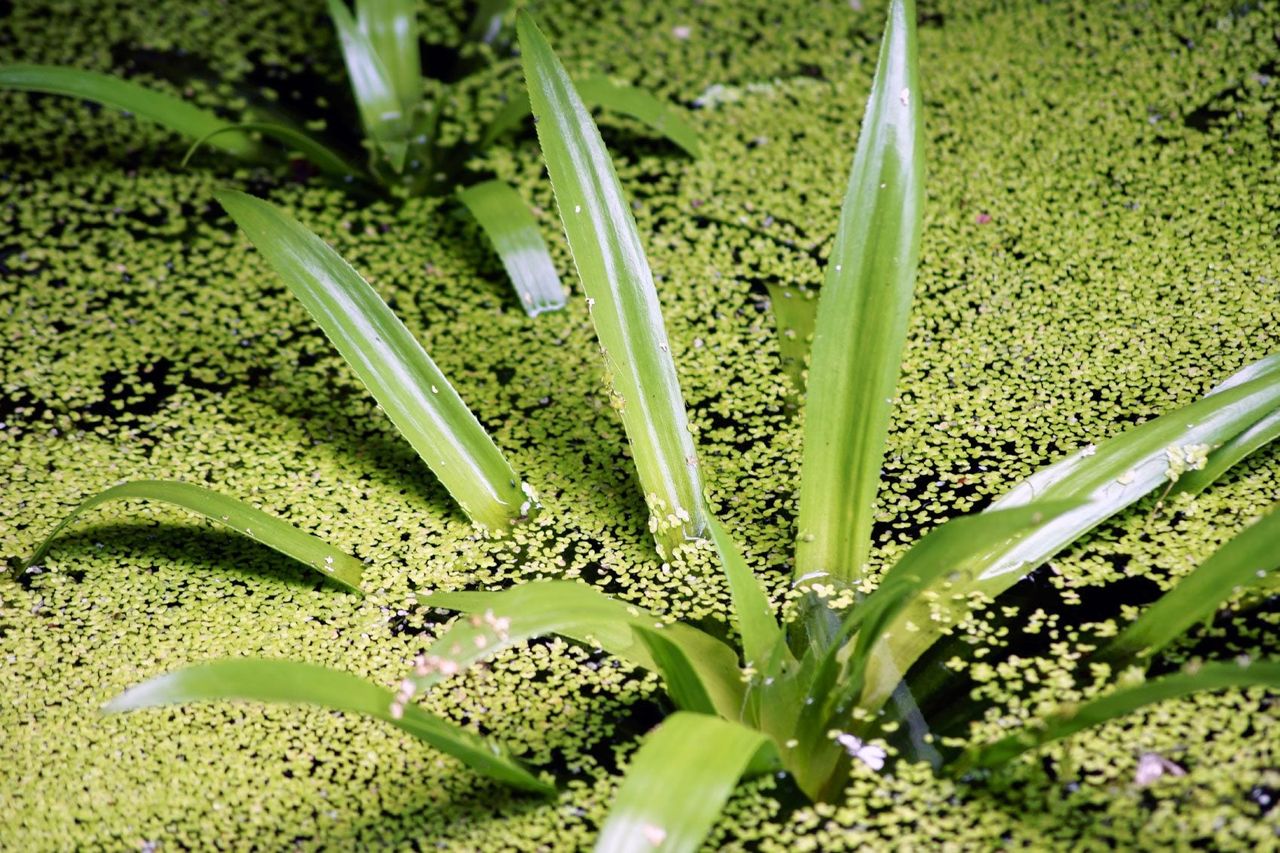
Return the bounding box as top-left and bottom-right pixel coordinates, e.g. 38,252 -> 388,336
329,0 -> 410,172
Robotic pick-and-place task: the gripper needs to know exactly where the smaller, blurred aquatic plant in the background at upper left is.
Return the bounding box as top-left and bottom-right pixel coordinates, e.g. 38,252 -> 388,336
0,0 -> 698,316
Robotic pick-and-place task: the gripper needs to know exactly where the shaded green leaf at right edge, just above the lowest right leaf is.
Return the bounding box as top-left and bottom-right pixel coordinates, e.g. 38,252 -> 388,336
1103,505 -> 1280,661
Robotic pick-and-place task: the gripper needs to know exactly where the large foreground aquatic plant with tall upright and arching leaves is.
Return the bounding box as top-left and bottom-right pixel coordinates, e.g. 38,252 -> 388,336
20,1 -> 1280,850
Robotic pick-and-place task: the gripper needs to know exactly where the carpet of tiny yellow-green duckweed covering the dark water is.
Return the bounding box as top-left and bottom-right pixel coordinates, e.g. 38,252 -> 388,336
0,0 -> 1280,849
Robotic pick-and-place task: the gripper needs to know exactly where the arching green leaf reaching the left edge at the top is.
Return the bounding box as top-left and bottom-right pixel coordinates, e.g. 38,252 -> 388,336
0,65 -> 261,160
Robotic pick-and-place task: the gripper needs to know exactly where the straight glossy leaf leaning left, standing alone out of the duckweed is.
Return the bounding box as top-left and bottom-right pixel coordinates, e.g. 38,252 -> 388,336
215,190 -> 529,530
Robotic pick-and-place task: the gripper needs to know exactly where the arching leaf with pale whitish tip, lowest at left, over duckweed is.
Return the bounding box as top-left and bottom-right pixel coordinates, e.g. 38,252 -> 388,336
102,658 -> 556,794
